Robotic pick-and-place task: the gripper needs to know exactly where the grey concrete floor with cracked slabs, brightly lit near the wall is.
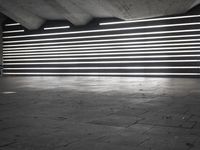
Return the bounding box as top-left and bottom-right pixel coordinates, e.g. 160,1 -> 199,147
0,77 -> 200,150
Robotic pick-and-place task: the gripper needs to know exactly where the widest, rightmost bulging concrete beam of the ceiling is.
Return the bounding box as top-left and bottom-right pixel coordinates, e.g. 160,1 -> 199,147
100,0 -> 199,20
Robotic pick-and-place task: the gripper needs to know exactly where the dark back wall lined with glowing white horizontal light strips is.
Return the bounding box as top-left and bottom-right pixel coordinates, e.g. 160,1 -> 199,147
3,16 -> 200,77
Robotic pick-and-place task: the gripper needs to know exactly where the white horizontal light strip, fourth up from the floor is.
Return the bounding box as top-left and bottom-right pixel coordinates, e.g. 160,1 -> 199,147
3,55 -> 200,62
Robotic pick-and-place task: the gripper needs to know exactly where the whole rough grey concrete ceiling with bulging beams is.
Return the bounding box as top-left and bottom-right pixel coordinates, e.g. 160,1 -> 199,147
0,0 -> 200,29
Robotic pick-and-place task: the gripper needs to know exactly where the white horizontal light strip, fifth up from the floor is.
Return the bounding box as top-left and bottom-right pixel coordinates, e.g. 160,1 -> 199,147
3,50 -> 200,59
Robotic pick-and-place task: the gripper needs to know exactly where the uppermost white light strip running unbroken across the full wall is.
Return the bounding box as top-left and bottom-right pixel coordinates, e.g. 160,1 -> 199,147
3,22 -> 200,39
